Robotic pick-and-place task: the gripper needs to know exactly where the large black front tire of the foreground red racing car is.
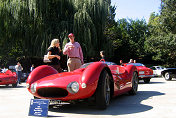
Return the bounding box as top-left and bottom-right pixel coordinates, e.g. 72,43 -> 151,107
96,70 -> 111,109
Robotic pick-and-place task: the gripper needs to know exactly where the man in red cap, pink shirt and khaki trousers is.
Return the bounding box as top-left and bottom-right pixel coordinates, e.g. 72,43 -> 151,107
63,33 -> 84,72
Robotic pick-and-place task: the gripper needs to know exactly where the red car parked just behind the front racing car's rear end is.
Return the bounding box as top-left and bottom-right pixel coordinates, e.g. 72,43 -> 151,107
125,63 -> 154,83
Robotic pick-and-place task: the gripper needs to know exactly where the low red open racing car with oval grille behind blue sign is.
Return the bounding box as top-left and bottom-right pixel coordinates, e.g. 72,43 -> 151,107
26,62 -> 138,109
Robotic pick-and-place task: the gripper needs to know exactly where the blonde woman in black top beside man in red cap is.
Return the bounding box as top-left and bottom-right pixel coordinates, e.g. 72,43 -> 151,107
47,39 -> 62,72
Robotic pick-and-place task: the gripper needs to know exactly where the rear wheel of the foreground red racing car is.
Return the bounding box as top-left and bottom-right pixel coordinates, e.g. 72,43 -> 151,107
128,72 -> 139,95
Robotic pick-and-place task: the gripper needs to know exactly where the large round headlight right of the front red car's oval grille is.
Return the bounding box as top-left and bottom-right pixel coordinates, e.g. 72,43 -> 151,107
67,81 -> 79,94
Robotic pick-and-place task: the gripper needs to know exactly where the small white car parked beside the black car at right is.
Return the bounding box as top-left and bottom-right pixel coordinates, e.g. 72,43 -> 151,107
150,66 -> 166,77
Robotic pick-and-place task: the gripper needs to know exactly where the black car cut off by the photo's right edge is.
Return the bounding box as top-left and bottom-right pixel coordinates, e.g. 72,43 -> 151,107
161,68 -> 176,81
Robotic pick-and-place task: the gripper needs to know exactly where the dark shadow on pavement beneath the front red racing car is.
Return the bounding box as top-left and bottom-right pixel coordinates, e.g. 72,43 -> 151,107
49,91 -> 164,115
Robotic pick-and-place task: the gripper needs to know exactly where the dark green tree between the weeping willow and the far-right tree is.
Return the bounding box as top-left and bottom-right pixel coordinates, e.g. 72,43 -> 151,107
108,19 -> 148,62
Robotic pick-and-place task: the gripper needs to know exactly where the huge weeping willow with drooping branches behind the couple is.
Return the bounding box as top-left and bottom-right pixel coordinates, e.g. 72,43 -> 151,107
0,0 -> 111,66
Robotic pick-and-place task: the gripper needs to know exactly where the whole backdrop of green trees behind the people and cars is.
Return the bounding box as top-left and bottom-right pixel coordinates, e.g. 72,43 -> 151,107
0,0 -> 176,66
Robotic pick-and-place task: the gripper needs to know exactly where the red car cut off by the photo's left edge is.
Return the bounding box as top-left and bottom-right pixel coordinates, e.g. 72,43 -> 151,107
0,70 -> 18,87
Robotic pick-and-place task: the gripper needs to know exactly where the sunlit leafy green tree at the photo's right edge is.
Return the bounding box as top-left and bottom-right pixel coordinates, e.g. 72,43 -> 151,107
145,0 -> 176,66
